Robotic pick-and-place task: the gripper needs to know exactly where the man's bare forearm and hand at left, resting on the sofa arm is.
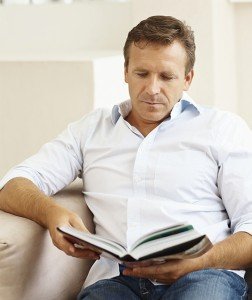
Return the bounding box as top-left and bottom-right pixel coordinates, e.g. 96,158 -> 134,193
0,177 -> 99,259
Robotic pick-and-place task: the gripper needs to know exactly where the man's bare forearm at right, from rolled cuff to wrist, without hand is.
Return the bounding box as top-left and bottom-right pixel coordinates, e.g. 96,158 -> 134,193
199,232 -> 252,270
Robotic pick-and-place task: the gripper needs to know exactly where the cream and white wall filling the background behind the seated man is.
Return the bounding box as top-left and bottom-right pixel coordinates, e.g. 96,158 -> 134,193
0,0 -> 252,177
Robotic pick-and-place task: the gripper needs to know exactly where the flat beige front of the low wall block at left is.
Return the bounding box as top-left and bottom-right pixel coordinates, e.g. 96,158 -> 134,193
0,62 -> 93,176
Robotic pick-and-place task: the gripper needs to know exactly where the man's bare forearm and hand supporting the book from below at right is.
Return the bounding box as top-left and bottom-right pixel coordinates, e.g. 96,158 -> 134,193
123,232 -> 252,284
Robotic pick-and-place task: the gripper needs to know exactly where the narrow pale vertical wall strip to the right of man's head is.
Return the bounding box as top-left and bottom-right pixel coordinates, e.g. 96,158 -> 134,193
212,0 -> 238,113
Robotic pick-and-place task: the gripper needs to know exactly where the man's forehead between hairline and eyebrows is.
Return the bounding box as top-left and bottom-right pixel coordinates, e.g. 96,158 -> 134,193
128,41 -> 186,69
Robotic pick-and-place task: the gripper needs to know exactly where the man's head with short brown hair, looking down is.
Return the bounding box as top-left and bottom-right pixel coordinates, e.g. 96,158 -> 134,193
124,16 -> 195,132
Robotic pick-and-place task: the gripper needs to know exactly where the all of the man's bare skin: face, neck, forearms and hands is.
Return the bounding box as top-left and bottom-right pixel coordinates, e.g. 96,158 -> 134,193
0,43 -> 252,284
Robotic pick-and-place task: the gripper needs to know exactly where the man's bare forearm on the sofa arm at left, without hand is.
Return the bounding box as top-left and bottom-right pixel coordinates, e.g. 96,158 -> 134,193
0,177 -> 57,227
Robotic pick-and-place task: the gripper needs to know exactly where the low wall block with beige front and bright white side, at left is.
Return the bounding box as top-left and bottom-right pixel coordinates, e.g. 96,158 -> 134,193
0,51 -> 128,177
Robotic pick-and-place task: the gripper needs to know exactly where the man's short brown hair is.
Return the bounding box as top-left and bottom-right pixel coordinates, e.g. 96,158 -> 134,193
123,16 -> 196,74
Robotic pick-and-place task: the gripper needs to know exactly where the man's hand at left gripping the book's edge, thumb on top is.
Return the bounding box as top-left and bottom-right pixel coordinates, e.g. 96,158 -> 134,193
46,204 -> 100,260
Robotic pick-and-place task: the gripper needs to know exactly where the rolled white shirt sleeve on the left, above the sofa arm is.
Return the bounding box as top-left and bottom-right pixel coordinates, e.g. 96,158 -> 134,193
0,110 -> 94,196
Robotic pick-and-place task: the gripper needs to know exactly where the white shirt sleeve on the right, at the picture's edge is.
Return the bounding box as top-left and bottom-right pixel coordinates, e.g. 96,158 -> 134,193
218,113 -> 252,234
